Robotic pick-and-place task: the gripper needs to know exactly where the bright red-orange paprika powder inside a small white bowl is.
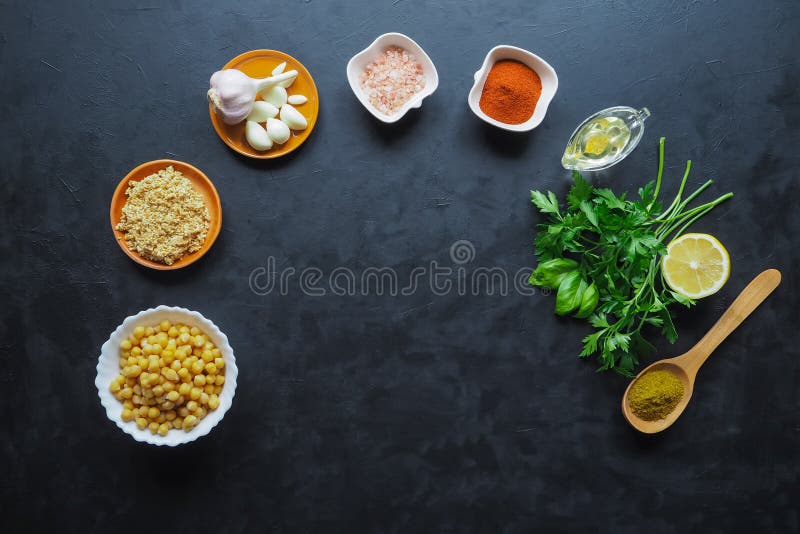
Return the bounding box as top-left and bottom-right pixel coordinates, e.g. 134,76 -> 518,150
479,59 -> 542,124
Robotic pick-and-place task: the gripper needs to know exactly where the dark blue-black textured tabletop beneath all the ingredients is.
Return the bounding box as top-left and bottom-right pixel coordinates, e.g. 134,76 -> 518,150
0,0 -> 800,533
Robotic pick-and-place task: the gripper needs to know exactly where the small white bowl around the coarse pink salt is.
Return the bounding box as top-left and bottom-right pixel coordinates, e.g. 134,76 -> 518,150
347,33 -> 439,123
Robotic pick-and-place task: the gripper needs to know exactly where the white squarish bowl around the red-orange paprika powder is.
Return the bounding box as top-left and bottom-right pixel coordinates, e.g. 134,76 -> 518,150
467,45 -> 558,132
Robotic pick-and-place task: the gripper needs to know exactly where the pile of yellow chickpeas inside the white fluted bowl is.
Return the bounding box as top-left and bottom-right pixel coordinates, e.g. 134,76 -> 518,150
109,321 -> 225,436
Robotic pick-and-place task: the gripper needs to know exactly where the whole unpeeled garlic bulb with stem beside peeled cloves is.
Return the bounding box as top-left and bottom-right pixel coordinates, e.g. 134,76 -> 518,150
208,69 -> 297,124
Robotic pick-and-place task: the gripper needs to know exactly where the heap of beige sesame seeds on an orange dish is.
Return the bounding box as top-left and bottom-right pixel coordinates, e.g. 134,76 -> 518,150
116,166 -> 210,265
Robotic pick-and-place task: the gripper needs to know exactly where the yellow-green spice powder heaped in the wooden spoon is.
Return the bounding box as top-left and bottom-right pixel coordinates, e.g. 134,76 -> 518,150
628,370 -> 683,421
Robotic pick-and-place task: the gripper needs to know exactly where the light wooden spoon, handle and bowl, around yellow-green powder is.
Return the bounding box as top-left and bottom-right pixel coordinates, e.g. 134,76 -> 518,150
622,269 -> 781,434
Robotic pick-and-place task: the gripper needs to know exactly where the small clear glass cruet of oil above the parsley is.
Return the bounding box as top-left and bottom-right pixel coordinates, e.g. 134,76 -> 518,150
561,106 -> 650,171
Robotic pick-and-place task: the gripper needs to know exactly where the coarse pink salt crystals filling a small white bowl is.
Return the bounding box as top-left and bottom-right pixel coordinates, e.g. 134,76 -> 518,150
360,46 -> 425,115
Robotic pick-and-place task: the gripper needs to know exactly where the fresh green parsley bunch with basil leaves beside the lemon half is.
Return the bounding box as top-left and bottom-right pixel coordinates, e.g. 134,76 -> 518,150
529,137 -> 733,376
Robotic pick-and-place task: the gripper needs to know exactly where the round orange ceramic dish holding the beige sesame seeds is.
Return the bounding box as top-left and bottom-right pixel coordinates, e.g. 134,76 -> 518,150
111,159 -> 222,271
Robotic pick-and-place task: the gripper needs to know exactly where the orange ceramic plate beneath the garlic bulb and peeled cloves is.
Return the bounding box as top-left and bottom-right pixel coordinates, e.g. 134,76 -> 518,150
208,50 -> 319,159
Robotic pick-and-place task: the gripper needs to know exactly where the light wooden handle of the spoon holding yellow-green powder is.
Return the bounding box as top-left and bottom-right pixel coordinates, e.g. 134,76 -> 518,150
685,269 -> 781,376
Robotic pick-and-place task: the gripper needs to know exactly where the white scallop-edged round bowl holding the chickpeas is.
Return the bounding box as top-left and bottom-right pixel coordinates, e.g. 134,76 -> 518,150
94,306 -> 239,447
